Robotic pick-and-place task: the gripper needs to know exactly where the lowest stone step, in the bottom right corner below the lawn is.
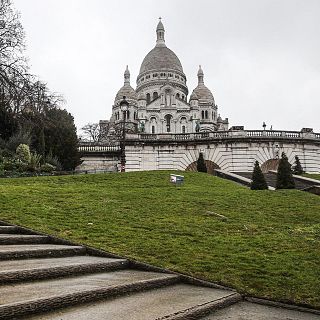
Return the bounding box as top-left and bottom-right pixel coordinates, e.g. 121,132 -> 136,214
202,302 -> 320,320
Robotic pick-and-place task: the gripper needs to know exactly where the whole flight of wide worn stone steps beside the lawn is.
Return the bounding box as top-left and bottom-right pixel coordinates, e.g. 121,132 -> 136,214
0,222 -> 320,320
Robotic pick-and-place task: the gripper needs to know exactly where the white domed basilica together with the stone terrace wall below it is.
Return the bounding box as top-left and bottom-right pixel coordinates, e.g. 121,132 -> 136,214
78,19 -> 320,172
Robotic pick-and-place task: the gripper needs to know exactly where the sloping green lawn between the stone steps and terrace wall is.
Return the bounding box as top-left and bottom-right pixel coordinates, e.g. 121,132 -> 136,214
0,171 -> 320,308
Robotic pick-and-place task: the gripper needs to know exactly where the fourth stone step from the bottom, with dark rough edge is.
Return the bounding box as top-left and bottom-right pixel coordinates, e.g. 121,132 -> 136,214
0,256 -> 128,284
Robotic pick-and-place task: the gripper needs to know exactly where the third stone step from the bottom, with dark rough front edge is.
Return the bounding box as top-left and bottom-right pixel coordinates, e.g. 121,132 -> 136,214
0,270 -> 180,319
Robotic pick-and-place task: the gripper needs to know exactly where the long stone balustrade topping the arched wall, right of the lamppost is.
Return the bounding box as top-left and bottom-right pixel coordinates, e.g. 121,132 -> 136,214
126,130 -> 320,141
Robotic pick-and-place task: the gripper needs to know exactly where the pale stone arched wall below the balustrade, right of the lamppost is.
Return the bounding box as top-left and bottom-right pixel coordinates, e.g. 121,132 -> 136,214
126,141 -> 320,172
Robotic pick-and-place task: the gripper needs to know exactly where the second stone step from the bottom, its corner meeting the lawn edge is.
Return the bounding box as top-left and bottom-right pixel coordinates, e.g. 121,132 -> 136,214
22,284 -> 241,320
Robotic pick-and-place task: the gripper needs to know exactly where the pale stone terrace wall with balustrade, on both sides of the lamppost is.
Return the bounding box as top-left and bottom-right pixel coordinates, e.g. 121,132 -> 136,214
79,130 -> 320,172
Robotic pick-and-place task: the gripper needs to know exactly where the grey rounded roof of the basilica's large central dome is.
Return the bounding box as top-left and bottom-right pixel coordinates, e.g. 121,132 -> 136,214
140,45 -> 183,74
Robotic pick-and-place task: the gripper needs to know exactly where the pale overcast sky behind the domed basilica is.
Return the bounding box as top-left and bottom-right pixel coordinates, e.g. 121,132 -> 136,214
13,0 -> 320,132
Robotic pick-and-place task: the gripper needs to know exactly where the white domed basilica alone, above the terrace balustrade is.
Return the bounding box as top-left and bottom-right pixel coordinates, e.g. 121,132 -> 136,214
104,19 -> 228,137
